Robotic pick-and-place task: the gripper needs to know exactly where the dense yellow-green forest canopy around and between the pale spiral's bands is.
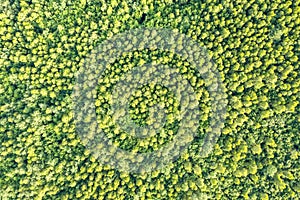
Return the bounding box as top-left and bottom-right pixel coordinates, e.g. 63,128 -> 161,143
0,0 -> 300,200
